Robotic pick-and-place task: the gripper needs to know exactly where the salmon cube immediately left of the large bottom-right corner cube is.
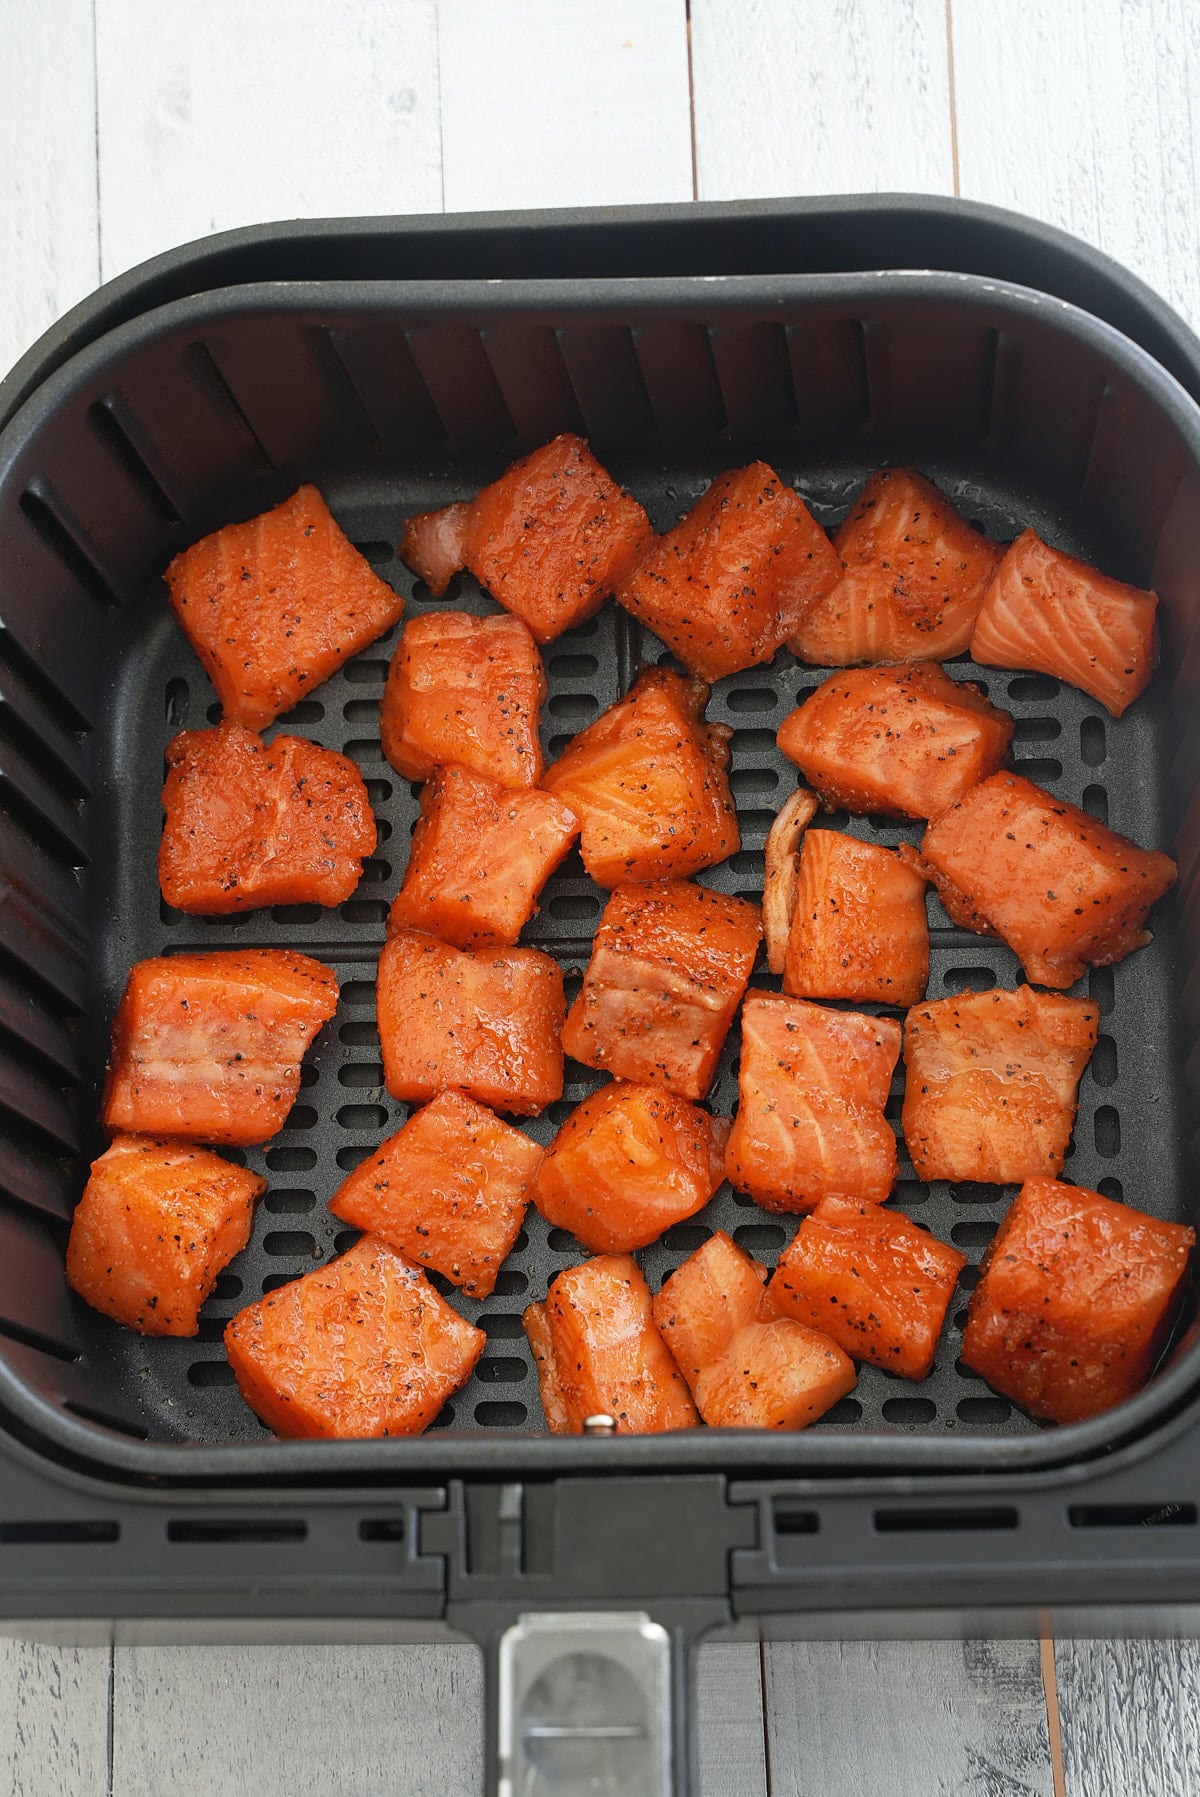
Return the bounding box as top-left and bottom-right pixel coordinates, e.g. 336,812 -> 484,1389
771,1199 -> 966,1378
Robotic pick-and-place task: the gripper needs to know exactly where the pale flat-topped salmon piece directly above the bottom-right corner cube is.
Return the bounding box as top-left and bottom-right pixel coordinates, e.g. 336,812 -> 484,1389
904,987 -> 1099,1186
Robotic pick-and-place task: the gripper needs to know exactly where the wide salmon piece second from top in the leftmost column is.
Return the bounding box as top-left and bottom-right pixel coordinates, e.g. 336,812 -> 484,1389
158,724 -> 375,916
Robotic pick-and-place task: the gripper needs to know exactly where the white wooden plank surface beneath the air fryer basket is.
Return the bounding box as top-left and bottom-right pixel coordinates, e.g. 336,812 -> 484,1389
0,0 -> 1200,1797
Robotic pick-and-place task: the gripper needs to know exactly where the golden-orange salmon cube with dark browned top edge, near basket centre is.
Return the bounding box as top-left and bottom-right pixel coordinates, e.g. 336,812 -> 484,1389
543,668 -> 738,888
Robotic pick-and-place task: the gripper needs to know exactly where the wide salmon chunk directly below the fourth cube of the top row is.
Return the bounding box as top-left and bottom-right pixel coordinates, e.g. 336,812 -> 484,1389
778,661 -> 1013,818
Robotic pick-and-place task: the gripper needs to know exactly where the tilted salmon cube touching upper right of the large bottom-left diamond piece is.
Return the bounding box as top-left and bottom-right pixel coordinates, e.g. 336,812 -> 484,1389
329,1093 -> 543,1297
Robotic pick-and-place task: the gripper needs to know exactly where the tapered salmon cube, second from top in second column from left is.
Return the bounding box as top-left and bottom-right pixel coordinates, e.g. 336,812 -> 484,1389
388,767 -> 578,949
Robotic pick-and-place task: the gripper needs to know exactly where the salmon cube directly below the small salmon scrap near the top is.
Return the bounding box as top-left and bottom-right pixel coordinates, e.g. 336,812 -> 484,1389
379,611 -> 546,785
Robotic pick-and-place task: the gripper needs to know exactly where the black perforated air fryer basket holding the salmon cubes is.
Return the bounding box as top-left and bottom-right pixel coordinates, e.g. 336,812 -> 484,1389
0,265 -> 1200,1479
